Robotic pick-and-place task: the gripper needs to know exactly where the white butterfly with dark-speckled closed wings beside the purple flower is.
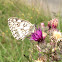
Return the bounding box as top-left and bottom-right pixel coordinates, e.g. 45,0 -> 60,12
8,17 -> 35,40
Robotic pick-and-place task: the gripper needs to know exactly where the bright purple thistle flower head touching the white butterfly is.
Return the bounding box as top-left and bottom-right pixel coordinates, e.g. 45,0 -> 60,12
30,29 -> 45,42
